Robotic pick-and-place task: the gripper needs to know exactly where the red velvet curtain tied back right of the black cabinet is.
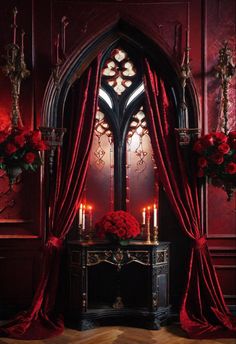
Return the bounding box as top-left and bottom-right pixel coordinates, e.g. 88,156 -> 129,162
144,60 -> 236,338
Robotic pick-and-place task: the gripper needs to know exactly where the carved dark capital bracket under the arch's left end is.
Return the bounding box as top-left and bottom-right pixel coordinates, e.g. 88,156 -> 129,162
39,127 -> 66,174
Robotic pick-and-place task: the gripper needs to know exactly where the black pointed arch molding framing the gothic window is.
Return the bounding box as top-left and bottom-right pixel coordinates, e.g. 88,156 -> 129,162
41,19 -> 199,128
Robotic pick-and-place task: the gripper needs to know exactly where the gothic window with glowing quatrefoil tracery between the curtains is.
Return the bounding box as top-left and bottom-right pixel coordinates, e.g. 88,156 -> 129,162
83,45 -> 158,226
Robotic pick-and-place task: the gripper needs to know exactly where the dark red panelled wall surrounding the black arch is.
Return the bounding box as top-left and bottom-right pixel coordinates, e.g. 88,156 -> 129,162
0,0 -> 236,316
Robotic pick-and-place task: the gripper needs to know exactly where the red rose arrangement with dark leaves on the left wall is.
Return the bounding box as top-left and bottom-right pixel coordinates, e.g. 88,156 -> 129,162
0,128 -> 46,184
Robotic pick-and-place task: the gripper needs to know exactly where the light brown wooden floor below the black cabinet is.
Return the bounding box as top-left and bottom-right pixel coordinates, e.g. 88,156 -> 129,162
0,325 -> 236,344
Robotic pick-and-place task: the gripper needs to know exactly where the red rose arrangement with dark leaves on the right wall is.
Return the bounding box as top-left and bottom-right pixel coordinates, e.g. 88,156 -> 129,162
193,131 -> 236,199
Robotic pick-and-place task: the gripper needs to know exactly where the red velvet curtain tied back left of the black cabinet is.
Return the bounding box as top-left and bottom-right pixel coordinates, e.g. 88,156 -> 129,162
0,56 -> 101,339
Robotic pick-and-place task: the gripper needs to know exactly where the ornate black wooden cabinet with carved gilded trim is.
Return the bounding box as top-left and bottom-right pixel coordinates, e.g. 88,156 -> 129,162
66,241 -> 170,330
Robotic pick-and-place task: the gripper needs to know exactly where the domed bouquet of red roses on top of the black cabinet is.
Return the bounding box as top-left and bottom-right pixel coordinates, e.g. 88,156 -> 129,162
95,210 -> 140,240
